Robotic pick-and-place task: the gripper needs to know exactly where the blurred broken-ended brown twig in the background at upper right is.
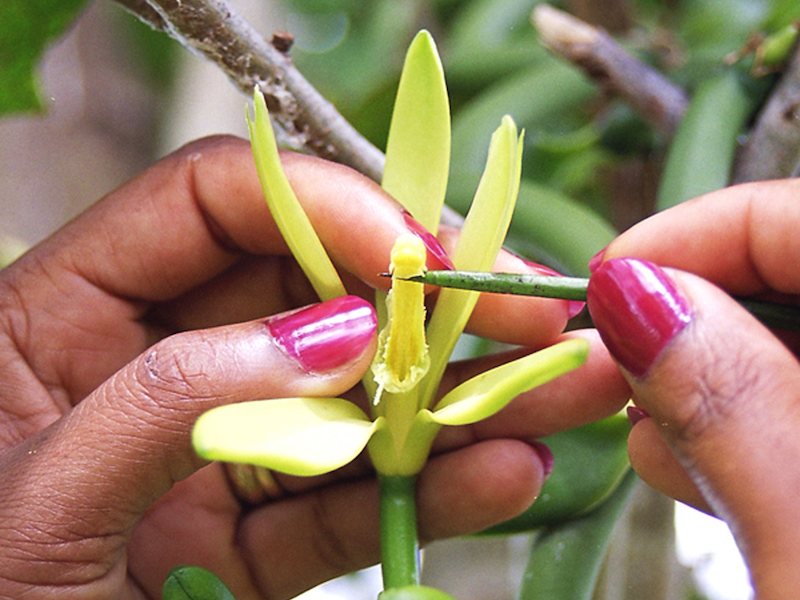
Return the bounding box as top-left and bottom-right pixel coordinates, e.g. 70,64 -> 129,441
531,4 -> 689,137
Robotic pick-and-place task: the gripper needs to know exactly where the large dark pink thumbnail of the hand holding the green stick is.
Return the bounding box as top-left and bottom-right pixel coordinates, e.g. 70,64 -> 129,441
586,258 -> 692,377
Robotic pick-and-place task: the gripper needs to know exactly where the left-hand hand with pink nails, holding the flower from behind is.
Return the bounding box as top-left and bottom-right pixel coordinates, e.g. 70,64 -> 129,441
0,138 -> 620,600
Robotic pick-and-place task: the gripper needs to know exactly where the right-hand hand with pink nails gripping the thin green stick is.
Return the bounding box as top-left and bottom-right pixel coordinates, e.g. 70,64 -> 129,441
588,180 -> 800,600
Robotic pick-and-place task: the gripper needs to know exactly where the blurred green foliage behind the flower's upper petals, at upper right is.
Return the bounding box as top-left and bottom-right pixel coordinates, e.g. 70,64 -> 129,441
283,0 -> 800,275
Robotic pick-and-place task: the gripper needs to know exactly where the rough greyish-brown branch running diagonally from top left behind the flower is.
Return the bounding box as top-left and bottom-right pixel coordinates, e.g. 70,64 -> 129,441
117,0 -> 384,181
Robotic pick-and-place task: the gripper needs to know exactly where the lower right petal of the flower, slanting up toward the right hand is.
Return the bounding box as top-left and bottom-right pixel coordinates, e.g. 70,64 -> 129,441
431,339 -> 589,425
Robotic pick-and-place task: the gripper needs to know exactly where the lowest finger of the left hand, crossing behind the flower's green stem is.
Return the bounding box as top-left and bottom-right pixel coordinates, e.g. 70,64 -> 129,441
230,440 -> 544,599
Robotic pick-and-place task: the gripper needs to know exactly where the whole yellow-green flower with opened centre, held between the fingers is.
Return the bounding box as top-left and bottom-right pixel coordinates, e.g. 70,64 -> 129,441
193,32 -> 588,476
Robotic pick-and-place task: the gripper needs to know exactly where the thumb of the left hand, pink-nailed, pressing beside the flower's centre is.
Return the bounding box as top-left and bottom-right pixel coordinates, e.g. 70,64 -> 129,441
0,296 -> 376,597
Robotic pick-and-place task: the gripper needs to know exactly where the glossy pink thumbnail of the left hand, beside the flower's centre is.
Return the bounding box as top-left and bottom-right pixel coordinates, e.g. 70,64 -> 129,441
267,296 -> 378,372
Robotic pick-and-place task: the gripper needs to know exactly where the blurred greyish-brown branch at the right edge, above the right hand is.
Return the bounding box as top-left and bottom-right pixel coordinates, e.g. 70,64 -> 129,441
733,47 -> 800,183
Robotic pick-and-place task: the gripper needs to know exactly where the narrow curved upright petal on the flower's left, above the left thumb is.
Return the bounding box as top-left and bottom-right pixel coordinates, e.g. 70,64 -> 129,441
247,88 -> 347,300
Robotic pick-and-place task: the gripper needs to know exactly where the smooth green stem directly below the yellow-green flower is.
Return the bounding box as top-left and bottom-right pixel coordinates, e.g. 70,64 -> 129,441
378,475 -> 419,590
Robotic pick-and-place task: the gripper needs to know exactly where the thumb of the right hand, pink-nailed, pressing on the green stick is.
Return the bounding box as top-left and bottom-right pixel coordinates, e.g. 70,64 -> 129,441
588,258 -> 800,598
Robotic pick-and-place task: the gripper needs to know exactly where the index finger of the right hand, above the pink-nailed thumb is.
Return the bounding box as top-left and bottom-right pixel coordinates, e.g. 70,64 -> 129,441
602,179 -> 800,295
